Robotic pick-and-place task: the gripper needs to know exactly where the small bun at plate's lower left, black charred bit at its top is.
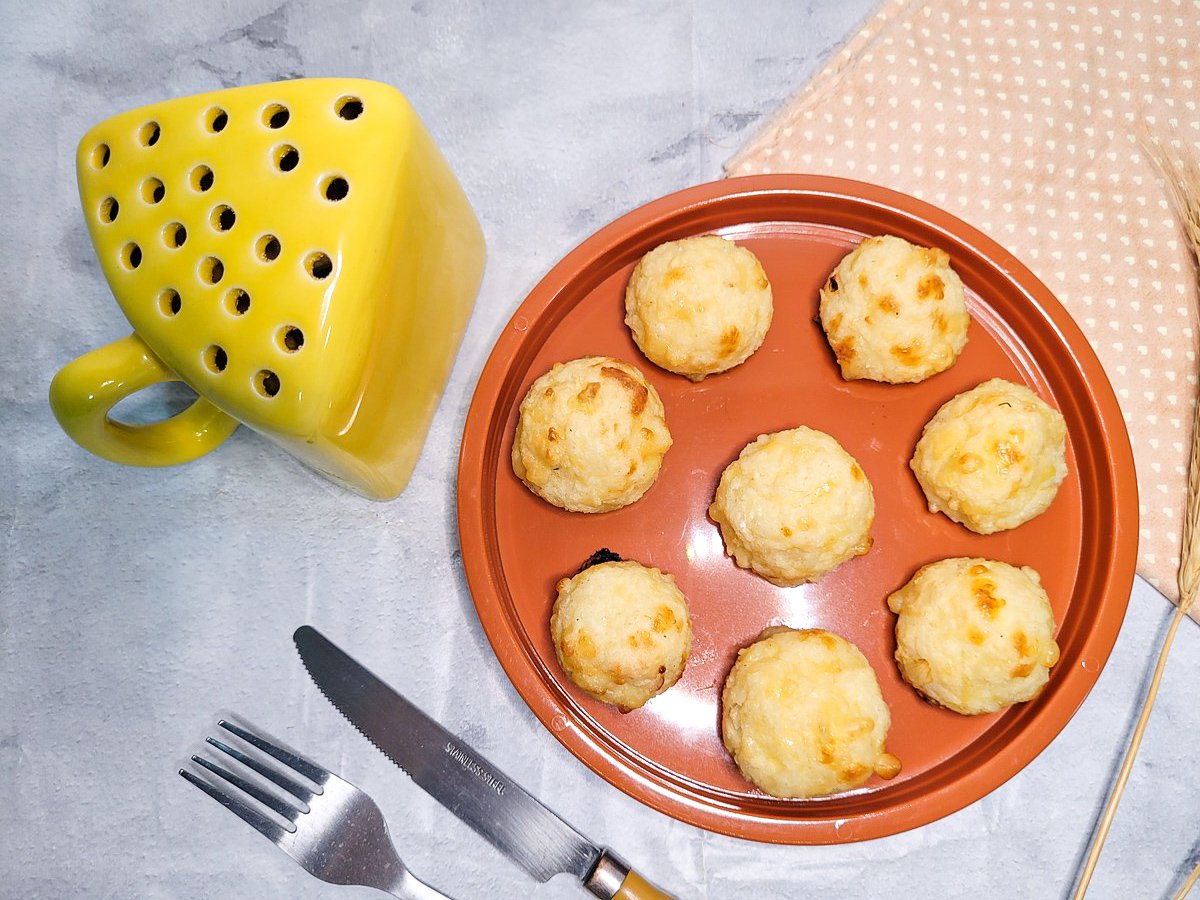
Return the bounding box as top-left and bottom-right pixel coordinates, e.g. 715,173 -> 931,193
550,559 -> 691,713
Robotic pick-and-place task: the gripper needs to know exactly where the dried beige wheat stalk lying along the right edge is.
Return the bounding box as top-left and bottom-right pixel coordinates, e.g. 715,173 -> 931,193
1075,123 -> 1200,900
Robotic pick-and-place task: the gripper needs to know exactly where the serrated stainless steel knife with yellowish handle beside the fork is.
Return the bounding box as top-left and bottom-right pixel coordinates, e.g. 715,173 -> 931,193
293,625 -> 670,900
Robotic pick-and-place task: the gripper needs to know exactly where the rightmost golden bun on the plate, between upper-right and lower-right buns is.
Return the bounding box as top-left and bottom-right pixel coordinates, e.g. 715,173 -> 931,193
908,378 -> 1067,534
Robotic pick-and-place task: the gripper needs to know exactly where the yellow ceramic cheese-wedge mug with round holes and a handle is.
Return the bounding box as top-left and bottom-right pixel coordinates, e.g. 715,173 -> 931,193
50,78 -> 485,499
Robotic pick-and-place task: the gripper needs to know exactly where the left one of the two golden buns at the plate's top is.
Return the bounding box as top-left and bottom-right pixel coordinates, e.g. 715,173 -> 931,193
625,234 -> 773,382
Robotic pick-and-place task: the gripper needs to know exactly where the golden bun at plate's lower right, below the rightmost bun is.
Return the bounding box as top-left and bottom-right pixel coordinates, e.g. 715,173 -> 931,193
888,558 -> 1058,715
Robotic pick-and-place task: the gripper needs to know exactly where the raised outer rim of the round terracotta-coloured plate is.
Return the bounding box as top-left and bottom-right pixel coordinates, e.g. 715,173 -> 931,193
457,175 -> 1138,844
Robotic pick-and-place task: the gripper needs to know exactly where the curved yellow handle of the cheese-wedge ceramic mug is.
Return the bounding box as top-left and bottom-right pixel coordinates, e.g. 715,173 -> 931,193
50,335 -> 238,466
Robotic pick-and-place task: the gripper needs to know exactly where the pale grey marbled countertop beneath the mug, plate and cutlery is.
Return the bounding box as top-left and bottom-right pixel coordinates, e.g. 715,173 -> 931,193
0,0 -> 1200,899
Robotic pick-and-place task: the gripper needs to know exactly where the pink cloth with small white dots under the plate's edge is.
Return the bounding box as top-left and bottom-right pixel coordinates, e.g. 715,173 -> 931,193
726,0 -> 1200,620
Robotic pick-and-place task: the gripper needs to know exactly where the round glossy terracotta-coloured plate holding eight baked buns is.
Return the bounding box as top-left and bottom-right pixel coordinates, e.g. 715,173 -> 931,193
458,175 -> 1138,844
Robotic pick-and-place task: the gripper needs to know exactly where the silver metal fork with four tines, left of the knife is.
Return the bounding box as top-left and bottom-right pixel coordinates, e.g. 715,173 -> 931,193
179,719 -> 450,900
